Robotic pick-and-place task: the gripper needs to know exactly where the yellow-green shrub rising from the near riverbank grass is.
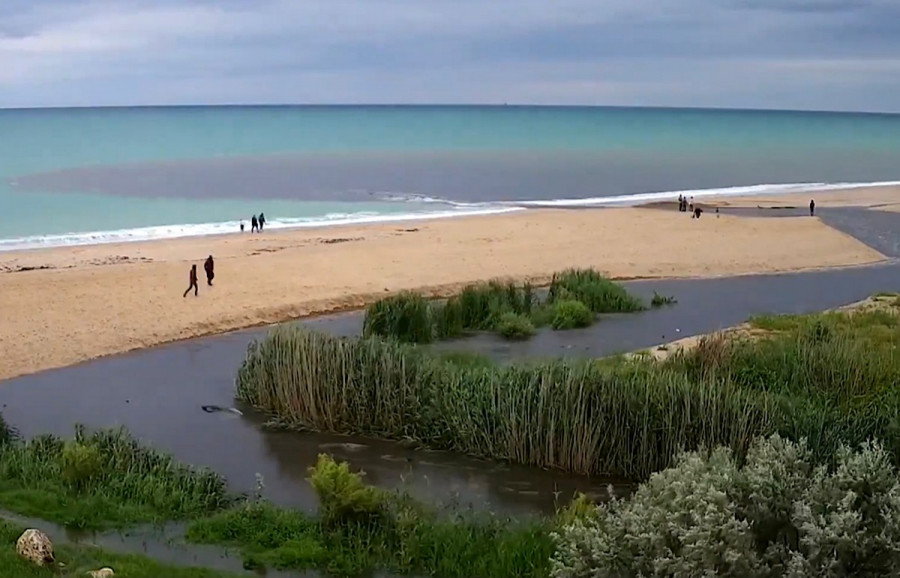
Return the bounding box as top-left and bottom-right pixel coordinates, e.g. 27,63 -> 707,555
309,454 -> 385,527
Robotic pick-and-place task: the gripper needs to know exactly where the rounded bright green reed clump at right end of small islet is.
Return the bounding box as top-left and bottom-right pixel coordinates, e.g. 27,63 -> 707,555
548,269 -> 646,313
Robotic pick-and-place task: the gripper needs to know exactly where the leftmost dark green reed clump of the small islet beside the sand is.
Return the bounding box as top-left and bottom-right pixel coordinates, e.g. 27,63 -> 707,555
363,292 -> 434,343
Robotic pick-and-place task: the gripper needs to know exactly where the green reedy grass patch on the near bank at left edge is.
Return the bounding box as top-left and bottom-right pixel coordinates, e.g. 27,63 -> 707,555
0,428 -> 233,529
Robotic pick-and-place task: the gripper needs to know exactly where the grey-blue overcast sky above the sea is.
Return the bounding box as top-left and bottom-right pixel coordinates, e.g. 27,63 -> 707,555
0,0 -> 900,112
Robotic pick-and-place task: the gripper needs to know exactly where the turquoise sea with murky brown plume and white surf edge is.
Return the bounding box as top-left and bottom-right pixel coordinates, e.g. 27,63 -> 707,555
0,106 -> 900,251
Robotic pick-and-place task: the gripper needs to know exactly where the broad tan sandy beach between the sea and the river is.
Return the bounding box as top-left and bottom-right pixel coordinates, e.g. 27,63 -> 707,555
0,208 -> 883,379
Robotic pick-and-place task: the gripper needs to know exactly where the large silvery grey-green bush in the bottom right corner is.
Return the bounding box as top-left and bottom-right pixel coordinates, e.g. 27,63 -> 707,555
551,435 -> 900,578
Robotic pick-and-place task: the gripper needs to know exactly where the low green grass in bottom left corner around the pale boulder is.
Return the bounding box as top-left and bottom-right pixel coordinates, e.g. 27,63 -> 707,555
0,519 -> 239,578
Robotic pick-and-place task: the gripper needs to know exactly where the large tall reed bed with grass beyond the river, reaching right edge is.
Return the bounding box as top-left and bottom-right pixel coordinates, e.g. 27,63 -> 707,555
238,296 -> 900,480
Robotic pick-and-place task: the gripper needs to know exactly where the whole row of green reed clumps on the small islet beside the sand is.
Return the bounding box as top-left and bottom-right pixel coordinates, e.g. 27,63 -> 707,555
363,269 -> 646,343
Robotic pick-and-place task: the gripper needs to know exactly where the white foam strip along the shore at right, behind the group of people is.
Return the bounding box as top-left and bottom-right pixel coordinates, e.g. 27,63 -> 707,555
506,181 -> 900,207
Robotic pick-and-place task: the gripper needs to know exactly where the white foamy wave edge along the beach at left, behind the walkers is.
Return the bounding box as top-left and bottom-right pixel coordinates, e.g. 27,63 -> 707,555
0,206 -> 524,252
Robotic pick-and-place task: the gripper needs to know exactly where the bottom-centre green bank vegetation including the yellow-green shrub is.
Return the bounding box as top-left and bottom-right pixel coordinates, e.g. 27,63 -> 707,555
187,456 -> 553,578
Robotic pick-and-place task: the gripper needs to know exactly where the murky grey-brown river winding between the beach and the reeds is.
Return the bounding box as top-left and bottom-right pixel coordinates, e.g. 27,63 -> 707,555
0,210 -> 900,516
